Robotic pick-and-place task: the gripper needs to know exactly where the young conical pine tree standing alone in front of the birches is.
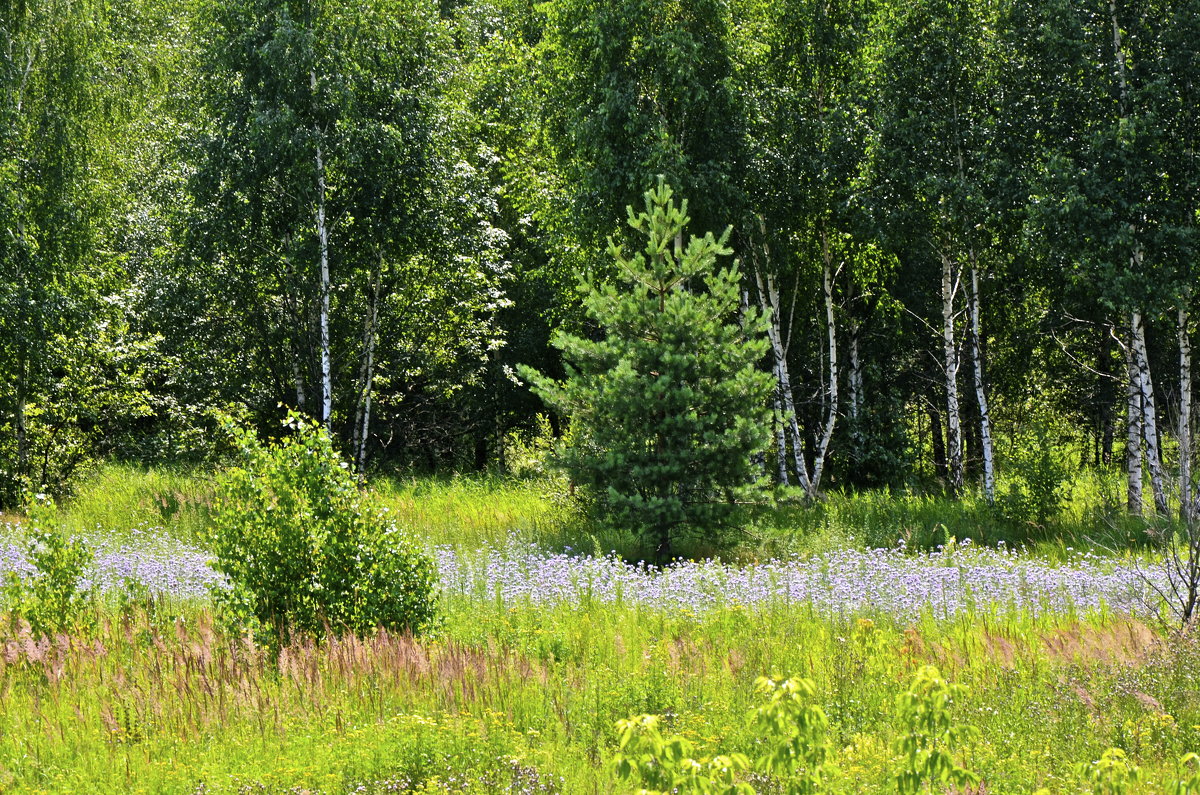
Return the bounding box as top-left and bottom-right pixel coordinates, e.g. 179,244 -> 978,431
522,179 -> 774,562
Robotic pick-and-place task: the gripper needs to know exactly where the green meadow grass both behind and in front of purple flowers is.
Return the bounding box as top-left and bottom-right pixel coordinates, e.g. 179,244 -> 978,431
0,465 -> 1200,795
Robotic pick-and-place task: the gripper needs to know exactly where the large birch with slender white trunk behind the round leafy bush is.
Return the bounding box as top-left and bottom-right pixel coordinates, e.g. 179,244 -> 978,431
188,0 -> 503,470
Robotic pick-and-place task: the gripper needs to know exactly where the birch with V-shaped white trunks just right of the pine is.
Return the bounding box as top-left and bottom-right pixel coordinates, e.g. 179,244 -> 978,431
738,0 -> 871,500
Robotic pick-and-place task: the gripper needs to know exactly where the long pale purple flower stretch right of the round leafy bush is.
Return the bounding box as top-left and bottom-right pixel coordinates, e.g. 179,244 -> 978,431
437,543 -> 1153,620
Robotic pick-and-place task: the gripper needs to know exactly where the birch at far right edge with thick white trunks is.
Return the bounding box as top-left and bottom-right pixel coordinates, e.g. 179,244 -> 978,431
1034,0 -> 1194,514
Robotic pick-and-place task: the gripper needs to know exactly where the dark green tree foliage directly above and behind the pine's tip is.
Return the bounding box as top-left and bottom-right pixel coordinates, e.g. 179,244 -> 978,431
541,0 -> 745,249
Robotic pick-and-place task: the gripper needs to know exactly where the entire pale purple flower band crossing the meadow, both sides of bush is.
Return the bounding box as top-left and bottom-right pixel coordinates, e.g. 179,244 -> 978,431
0,527 -> 1159,622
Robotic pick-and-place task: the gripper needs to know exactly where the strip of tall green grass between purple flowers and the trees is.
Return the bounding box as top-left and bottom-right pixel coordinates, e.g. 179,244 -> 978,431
39,464 -> 1171,560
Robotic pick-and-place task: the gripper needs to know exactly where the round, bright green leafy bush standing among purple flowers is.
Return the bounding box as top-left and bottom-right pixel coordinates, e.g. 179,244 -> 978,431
208,416 -> 437,645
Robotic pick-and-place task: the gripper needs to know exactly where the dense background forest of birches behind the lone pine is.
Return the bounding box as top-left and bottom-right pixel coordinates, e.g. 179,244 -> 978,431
0,0 -> 1200,512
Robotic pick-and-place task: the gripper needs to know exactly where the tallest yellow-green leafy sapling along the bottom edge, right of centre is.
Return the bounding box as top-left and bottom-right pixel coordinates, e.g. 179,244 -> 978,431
895,665 -> 979,795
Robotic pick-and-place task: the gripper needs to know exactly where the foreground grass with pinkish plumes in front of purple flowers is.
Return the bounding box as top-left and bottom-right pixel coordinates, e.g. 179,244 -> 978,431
0,597 -> 1200,793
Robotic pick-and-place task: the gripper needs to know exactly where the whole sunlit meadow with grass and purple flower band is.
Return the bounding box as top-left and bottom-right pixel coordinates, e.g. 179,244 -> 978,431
0,467 -> 1200,794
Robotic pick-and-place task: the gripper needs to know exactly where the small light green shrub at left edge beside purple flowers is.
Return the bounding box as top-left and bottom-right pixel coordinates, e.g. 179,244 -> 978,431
4,495 -> 95,636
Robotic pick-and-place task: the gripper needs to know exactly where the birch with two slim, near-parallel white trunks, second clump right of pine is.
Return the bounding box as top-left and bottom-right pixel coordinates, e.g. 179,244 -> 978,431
871,0 -> 995,501
